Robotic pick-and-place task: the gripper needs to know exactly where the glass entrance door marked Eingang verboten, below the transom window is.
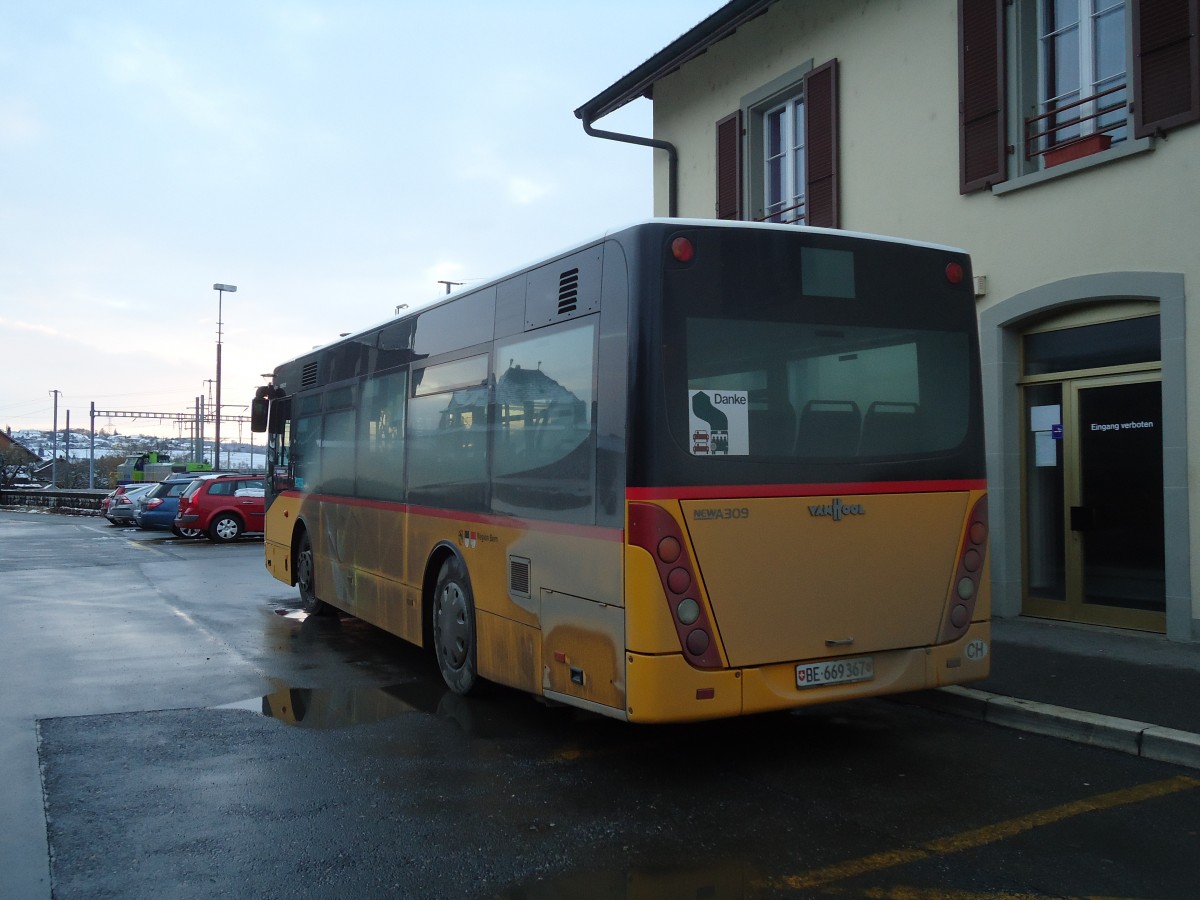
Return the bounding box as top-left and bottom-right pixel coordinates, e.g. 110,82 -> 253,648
1025,373 -> 1166,631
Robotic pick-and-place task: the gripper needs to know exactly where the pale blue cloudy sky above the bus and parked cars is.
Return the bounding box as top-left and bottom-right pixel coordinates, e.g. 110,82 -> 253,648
0,0 -> 724,439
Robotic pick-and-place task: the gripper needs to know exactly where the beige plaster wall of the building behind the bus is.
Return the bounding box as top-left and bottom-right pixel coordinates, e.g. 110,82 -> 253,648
654,0 -> 1200,640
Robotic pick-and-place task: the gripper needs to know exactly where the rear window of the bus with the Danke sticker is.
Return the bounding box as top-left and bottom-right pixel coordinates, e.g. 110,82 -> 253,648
676,318 -> 971,461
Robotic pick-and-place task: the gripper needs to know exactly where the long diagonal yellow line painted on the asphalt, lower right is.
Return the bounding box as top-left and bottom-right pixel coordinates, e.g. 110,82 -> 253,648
764,775 -> 1200,890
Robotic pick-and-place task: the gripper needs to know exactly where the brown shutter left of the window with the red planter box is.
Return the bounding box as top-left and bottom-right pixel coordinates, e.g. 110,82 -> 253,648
959,0 -> 1007,193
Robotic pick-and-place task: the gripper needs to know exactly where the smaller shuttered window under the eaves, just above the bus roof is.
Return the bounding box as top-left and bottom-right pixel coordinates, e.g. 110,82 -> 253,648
716,60 -> 840,228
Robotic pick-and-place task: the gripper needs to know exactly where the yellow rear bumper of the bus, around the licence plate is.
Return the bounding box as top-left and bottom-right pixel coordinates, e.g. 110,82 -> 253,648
626,622 -> 991,722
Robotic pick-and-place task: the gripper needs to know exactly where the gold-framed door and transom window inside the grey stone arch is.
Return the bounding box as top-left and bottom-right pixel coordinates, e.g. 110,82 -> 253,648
1020,304 -> 1166,631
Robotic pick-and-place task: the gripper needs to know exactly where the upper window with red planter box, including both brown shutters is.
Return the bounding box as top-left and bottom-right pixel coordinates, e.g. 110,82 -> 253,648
959,0 -> 1200,193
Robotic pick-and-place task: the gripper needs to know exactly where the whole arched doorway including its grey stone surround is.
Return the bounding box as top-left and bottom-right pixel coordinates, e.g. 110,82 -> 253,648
980,272 -> 1195,641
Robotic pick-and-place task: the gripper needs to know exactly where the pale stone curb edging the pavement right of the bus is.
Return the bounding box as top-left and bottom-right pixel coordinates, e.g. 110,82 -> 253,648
907,685 -> 1200,769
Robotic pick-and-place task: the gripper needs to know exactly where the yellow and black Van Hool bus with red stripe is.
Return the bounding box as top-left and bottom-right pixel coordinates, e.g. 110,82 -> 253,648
252,220 -> 990,722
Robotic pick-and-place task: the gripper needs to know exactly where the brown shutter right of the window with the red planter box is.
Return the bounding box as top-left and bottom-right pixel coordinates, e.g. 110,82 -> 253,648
1130,0 -> 1200,138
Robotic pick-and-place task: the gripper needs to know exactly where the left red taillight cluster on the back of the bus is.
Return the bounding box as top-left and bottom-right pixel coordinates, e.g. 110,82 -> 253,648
629,503 -> 721,668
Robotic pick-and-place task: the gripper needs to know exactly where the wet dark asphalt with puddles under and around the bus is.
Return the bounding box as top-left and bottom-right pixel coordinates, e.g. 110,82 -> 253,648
7,512 -> 1200,900
